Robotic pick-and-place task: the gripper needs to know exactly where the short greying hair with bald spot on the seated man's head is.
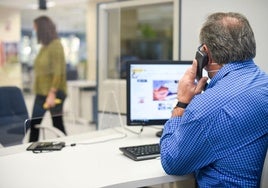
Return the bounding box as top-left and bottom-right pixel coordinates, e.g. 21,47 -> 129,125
199,12 -> 256,64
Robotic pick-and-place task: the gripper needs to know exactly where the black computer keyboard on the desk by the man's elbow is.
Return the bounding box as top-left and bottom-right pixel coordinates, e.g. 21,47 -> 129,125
119,143 -> 160,161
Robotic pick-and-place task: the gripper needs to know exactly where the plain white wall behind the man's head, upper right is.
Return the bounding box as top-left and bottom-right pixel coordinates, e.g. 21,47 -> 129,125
181,0 -> 268,73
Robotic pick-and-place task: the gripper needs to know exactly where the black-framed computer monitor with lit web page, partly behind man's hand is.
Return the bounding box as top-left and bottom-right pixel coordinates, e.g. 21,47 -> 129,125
126,60 -> 192,125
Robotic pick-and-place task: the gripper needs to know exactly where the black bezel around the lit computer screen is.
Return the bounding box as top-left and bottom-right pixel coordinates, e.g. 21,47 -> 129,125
126,60 -> 192,126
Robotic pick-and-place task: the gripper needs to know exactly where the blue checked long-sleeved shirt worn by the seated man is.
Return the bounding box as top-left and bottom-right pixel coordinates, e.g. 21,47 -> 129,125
160,60 -> 268,187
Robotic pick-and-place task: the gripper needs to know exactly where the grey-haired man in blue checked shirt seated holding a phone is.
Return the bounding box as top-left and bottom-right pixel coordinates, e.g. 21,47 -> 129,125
160,13 -> 268,188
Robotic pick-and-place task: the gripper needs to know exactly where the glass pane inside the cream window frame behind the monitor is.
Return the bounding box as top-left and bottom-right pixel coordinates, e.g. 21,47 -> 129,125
107,2 -> 173,79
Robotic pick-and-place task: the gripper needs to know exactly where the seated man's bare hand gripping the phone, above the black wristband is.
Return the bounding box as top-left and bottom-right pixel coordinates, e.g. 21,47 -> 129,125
177,60 -> 208,103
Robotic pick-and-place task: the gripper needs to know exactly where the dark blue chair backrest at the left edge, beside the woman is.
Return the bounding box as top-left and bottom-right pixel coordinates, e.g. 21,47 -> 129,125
0,86 -> 29,147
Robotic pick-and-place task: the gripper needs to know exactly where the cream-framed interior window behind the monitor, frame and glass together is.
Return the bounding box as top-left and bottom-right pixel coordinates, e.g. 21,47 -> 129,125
97,0 -> 179,117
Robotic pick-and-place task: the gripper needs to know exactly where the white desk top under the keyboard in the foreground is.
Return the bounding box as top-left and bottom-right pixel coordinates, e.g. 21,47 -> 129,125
0,128 -> 193,188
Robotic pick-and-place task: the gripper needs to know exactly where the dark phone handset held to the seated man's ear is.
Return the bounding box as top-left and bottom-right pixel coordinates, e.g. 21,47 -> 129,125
195,50 -> 208,81
